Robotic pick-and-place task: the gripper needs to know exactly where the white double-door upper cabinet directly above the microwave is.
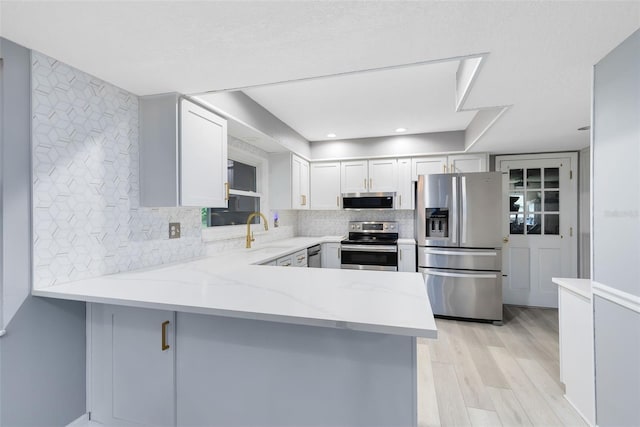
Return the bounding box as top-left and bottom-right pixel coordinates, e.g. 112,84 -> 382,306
340,159 -> 398,193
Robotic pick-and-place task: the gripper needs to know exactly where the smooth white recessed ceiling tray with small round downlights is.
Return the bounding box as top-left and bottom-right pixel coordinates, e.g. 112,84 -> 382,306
243,61 -> 475,141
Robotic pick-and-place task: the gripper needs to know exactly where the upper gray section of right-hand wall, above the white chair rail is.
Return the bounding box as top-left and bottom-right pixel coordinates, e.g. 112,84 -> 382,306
592,30 -> 640,296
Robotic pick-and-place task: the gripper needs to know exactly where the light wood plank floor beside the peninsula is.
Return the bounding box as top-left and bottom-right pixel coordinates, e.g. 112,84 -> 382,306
418,306 -> 587,427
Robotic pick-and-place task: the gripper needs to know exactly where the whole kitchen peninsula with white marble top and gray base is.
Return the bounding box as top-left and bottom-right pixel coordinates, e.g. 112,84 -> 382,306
33,238 -> 437,426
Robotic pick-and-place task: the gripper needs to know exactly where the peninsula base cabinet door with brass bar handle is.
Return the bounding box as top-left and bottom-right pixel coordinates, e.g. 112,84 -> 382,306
89,304 -> 176,426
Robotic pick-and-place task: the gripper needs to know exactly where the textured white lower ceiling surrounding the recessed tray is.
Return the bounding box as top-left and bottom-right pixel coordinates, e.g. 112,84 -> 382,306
0,0 -> 640,153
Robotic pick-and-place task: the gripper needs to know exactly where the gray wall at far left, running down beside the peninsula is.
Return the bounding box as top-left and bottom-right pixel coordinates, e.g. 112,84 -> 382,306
0,39 -> 85,426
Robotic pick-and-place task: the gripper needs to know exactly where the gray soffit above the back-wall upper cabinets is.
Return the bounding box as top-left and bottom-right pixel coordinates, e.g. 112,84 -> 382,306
311,131 -> 464,160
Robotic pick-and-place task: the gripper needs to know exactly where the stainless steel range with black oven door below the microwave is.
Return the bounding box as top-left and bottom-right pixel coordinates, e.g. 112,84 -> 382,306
340,221 -> 398,271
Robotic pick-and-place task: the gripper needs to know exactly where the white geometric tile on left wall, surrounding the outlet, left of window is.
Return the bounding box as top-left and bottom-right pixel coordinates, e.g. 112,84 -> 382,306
32,52 -> 204,288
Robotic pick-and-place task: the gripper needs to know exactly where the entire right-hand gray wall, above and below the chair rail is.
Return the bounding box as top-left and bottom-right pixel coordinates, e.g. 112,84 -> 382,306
591,30 -> 640,427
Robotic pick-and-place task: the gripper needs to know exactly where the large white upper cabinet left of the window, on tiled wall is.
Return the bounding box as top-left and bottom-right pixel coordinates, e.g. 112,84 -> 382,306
140,94 -> 227,208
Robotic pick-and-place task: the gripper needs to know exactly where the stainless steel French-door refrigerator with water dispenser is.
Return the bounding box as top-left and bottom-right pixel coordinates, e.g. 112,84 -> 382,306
415,172 -> 502,323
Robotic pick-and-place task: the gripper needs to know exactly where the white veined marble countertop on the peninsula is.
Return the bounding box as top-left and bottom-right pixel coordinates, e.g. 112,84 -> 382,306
32,236 -> 437,338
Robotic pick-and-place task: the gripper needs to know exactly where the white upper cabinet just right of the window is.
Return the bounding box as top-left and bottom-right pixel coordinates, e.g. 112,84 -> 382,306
269,153 -> 309,209
